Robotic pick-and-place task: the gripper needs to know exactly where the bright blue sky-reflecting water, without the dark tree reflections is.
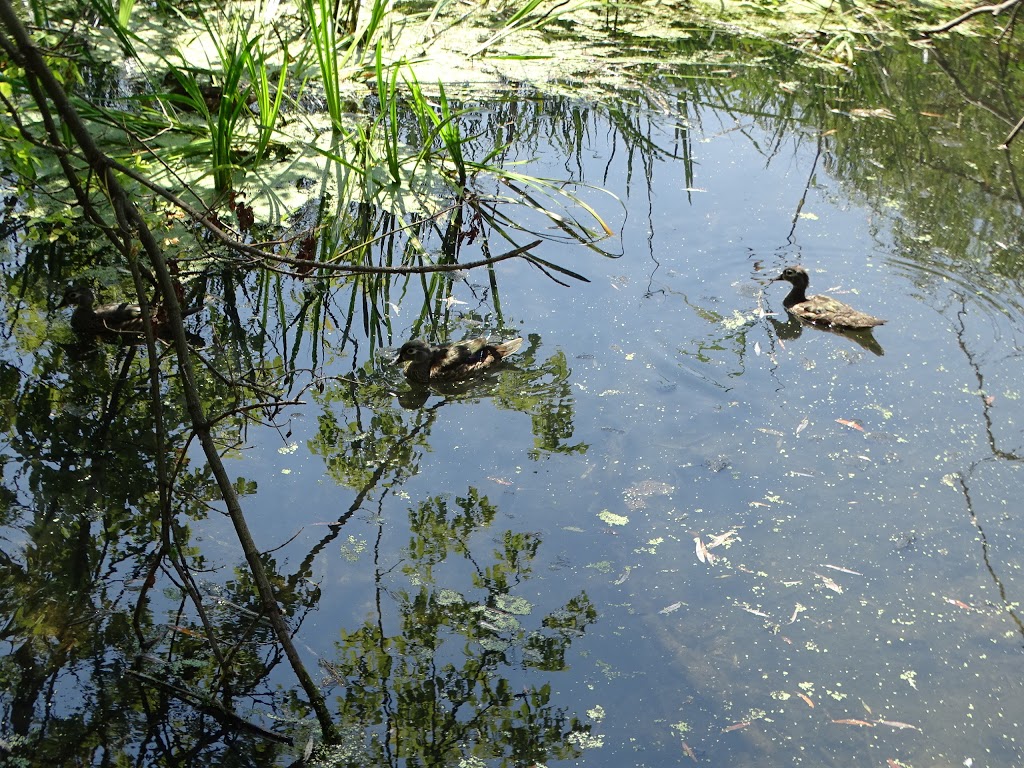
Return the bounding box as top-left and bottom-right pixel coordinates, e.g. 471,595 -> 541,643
238,58 -> 1024,766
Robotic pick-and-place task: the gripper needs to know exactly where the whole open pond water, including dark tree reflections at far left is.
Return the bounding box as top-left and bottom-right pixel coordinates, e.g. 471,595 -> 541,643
0,27 -> 1024,768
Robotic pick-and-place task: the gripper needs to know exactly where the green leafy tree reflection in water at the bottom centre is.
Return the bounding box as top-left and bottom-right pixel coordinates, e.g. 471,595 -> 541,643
325,487 -> 597,765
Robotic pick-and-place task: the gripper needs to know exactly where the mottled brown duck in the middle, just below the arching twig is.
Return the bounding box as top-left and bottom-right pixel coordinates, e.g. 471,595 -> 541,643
394,336 -> 522,384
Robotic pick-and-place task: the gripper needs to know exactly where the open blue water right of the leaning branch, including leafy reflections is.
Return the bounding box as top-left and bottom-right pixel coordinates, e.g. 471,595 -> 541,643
6,34 -> 1024,768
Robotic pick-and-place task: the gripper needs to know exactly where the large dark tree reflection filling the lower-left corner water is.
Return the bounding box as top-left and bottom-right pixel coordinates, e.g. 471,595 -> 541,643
0,345 -> 294,765
